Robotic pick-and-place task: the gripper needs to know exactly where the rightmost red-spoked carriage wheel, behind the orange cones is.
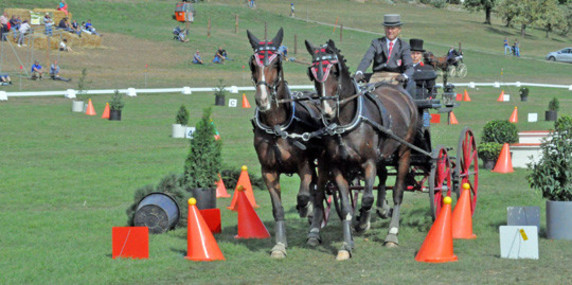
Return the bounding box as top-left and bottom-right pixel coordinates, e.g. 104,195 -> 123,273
454,127 -> 479,214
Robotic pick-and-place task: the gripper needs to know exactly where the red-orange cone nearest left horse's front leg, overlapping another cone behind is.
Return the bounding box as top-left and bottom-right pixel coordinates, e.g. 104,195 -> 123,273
234,187 -> 270,239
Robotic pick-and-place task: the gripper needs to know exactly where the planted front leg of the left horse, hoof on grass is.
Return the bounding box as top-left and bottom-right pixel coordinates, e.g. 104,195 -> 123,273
262,170 -> 288,258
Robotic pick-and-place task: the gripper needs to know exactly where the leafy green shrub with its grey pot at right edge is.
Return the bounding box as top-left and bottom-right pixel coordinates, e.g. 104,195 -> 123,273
527,116 -> 572,240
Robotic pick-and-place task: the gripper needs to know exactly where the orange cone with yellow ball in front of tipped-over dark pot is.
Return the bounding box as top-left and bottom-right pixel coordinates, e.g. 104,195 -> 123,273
185,198 -> 225,261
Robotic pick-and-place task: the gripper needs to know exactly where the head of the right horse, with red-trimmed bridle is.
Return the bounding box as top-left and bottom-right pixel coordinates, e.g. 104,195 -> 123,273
305,40 -> 351,119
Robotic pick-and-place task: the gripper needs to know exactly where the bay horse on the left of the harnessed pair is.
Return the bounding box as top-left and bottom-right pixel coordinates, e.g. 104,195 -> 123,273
247,28 -> 322,258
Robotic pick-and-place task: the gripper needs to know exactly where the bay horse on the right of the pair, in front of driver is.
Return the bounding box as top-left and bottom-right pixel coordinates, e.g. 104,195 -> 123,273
306,40 -> 418,260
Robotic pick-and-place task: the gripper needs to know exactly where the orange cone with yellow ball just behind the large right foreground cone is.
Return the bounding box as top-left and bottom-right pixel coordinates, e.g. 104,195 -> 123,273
452,183 -> 477,239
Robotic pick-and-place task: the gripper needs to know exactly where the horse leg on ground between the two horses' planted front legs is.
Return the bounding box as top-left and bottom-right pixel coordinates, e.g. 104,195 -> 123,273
306,160 -> 328,247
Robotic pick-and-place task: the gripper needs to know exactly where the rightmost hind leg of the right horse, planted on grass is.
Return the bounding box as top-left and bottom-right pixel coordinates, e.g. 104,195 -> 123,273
385,149 -> 411,247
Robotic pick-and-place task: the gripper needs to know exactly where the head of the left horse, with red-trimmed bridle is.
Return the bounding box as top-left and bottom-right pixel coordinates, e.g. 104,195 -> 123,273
246,28 -> 284,112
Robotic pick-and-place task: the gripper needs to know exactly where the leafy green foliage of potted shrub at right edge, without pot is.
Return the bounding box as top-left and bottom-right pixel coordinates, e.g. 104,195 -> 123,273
526,116 -> 572,201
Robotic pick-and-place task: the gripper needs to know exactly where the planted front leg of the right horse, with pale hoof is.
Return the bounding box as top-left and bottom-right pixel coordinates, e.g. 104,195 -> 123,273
333,169 -> 354,260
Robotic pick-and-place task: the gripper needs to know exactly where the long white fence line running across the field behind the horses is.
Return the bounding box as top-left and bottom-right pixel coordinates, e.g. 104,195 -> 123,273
0,81 -> 572,101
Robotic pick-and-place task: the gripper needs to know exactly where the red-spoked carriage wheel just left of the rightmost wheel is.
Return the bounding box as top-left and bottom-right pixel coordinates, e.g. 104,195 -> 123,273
429,146 -> 452,220
